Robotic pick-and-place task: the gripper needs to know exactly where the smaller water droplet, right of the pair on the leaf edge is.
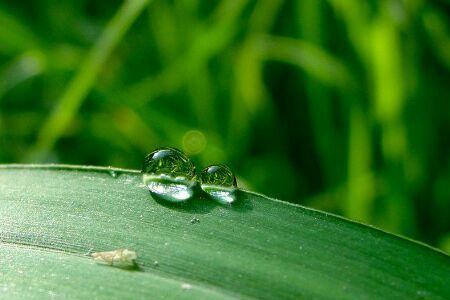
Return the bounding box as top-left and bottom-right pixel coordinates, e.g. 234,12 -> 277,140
200,165 -> 237,204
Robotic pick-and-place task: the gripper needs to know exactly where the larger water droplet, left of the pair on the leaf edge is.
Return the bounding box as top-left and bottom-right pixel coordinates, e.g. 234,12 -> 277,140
142,148 -> 195,202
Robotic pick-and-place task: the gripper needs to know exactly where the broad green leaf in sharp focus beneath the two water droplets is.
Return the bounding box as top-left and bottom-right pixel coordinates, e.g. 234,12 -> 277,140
0,165 -> 450,299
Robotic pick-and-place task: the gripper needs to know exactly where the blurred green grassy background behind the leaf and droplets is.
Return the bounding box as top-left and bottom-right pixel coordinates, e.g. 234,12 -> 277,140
0,0 -> 450,251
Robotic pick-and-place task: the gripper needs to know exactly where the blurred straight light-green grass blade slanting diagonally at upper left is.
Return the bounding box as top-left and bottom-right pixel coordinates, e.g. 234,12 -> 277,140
25,0 -> 149,161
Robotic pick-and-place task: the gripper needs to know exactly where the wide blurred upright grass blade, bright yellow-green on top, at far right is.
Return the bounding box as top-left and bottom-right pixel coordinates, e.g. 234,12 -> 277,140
371,7 -> 415,234
